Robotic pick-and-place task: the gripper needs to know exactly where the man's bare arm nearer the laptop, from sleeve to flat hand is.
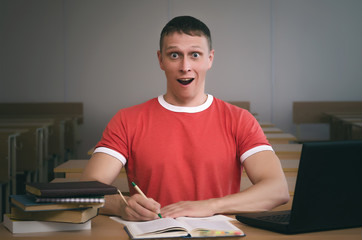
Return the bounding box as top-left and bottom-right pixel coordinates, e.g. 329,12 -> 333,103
161,151 -> 289,217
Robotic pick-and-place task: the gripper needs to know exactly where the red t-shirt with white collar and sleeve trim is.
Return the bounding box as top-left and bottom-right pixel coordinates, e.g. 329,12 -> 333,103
95,95 -> 272,206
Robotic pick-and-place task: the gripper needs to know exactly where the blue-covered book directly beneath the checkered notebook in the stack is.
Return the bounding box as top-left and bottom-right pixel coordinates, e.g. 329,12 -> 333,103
10,194 -> 104,211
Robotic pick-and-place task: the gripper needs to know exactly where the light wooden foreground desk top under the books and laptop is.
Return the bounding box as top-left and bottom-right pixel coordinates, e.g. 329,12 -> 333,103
0,215 -> 362,240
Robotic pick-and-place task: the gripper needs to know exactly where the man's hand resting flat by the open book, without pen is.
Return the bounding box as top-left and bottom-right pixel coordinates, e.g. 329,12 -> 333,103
161,199 -> 217,218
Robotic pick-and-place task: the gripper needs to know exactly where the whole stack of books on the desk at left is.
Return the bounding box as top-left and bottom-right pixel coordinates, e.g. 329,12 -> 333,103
4,181 -> 118,233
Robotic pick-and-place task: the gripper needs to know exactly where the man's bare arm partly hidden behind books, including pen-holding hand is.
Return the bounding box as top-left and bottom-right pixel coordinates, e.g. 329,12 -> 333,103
81,153 -> 160,221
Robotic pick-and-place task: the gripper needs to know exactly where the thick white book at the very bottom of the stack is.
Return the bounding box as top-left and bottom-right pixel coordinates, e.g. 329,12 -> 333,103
3,214 -> 92,233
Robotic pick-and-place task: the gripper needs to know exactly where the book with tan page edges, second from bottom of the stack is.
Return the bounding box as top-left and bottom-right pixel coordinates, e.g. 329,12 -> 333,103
10,207 -> 98,223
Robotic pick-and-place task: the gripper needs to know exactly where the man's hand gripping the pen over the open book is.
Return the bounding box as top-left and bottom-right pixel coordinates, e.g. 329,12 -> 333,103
121,194 -> 161,221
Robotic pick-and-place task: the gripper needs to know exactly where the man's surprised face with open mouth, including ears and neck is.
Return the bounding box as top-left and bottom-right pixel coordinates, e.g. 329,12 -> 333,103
157,32 -> 214,106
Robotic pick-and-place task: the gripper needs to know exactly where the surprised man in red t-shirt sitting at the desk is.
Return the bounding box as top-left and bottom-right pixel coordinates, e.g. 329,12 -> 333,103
82,16 -> 289,221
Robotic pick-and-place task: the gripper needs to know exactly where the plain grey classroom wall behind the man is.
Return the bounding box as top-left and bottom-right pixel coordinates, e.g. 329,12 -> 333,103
0,0 -> 362,157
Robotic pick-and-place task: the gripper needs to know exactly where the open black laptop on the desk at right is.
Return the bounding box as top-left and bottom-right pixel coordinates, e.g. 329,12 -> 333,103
236,140 -> 362,234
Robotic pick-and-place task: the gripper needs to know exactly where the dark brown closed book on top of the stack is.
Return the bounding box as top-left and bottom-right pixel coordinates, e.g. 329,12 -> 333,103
25,181 -> 118,197
